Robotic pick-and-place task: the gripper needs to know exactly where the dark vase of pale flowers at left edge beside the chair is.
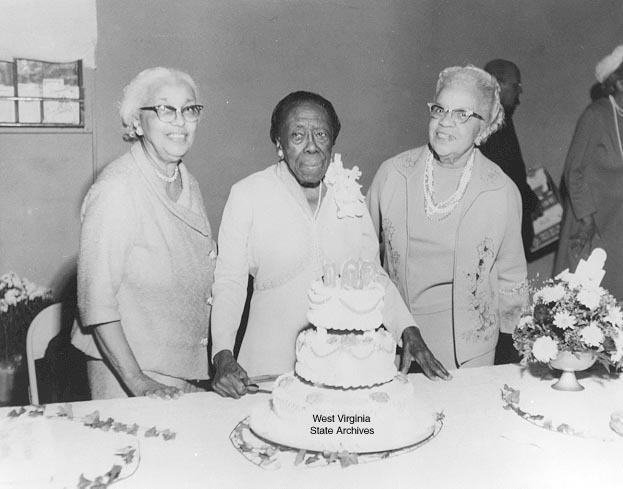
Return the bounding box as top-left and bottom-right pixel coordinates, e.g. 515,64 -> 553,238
0,272 -> 53,406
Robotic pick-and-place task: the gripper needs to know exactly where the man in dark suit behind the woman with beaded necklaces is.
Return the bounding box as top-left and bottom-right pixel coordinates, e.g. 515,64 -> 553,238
480,59 -> 542,264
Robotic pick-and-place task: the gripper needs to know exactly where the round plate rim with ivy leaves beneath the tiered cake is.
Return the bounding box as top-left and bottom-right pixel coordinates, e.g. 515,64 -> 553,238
229,404 -> 444,470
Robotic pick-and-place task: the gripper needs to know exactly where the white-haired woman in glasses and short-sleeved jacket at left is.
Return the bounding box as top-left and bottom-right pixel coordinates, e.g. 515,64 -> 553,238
72,68 -> 216,399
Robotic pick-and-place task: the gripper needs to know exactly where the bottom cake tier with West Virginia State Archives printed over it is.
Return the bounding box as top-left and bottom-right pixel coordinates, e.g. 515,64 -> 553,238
251,373 -> 436,453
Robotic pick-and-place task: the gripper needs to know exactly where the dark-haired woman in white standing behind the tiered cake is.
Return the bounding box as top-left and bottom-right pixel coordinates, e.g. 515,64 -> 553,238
211,92 -> 448,398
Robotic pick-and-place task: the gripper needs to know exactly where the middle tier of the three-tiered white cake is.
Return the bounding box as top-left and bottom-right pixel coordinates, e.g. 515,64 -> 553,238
294,328 -> 397,388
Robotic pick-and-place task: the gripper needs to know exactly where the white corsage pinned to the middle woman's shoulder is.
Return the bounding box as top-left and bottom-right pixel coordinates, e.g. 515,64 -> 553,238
324,153 -> 366,218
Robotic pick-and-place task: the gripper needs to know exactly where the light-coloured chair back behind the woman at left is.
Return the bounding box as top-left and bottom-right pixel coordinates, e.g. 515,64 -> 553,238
26,302 -> 63,404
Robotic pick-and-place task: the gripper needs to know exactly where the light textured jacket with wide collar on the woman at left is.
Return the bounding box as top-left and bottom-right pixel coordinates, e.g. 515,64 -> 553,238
72,143 -> 216,379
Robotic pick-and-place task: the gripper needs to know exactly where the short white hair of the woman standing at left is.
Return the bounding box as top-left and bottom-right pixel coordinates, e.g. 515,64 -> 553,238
119,66 -> 199,141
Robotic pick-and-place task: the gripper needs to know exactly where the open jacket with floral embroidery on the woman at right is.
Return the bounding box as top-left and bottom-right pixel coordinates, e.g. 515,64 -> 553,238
367,146 -> 528,364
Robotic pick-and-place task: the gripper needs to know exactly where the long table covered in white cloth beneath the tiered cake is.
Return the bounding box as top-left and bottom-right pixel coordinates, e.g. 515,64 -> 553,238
0,365 -> 623,489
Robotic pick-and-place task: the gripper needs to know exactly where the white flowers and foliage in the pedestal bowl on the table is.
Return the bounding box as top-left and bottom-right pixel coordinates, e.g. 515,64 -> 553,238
513,249 -> 623,369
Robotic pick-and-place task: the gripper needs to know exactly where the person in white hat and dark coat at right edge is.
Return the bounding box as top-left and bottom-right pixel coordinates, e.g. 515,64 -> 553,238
554,45 -> 623,300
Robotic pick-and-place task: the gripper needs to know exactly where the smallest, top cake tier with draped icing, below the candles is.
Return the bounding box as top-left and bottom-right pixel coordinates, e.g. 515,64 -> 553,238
307,281 -> 385,331
